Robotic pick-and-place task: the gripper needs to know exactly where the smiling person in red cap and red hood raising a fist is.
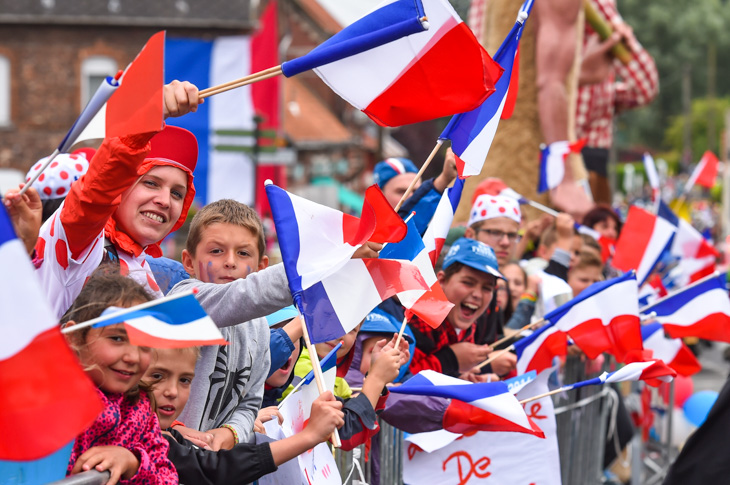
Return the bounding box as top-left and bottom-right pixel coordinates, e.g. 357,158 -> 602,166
31,81 -> 199,316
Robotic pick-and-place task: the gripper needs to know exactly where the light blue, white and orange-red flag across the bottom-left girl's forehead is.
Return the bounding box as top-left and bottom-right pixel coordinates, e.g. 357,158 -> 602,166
78,292 -> 228,349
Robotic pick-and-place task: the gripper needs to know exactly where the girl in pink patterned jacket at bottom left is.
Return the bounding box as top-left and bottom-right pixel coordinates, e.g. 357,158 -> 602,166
63,268 -> 178,484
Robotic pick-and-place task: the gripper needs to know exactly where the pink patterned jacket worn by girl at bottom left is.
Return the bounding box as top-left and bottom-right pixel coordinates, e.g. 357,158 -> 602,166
66,390 -> 178,485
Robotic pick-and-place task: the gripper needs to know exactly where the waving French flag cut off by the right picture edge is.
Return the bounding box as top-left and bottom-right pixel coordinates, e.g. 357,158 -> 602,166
642,273 -> 730,342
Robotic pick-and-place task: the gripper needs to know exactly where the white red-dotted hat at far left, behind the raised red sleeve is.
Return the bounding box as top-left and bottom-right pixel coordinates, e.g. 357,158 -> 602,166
25,151 -> 89,200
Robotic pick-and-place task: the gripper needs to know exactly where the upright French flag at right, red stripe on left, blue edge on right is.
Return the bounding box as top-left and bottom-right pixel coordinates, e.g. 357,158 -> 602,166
612,205 -> 678,286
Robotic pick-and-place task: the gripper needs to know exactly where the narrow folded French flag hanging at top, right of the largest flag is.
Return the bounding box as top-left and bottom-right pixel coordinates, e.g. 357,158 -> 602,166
439,0 -> 532,177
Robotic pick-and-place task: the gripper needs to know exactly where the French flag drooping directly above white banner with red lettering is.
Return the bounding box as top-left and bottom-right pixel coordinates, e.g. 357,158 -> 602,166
390,370 -> 545,438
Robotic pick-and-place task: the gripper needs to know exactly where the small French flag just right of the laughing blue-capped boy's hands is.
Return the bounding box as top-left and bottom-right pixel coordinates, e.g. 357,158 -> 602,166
513,322 -> 568,375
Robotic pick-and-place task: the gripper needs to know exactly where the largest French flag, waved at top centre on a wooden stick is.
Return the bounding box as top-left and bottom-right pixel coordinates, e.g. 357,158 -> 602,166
292,0 -> 500,126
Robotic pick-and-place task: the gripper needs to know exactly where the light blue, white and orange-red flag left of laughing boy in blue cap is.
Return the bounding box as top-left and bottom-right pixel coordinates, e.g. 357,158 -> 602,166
380,220 -> 454,328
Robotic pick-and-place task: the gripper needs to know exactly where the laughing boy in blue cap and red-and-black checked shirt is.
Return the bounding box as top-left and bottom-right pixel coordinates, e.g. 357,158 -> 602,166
409,238 -> 511,379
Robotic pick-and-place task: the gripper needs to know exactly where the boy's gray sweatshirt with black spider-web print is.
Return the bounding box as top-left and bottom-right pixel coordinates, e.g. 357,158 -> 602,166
168,264 -> 292,443
